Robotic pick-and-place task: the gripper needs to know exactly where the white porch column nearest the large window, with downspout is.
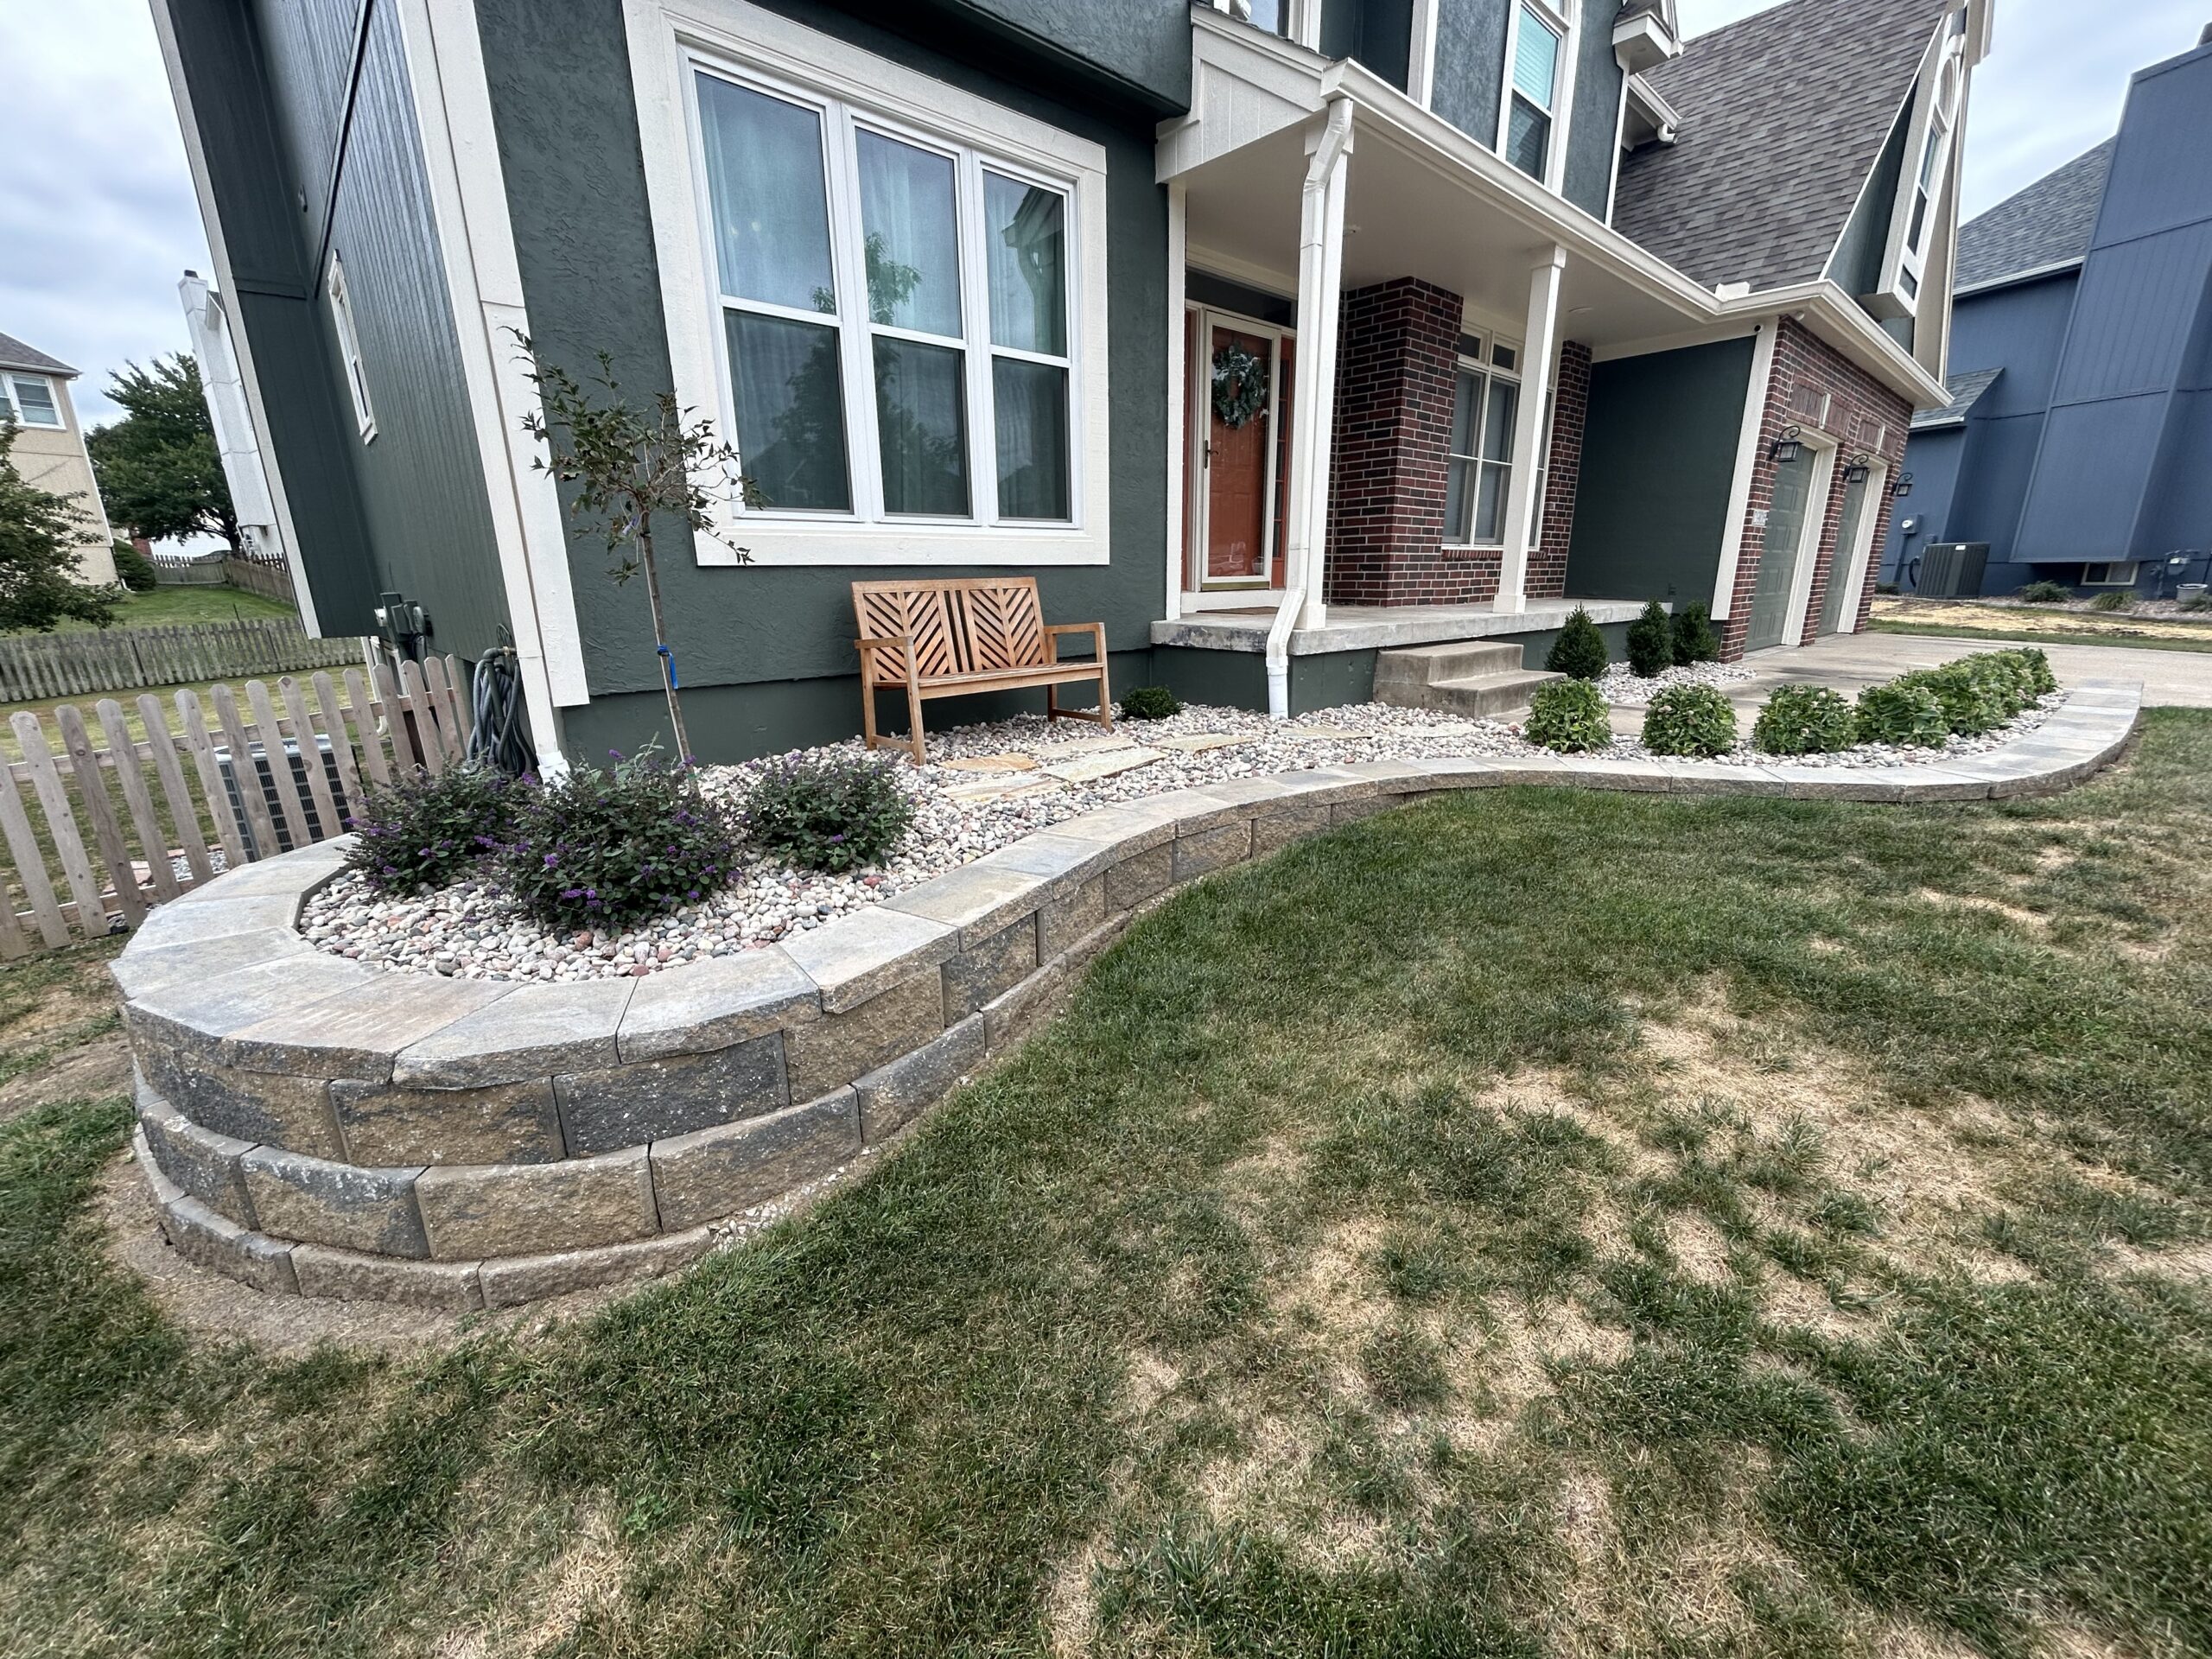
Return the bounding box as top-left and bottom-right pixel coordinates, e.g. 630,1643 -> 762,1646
1283,98 -> 1351,628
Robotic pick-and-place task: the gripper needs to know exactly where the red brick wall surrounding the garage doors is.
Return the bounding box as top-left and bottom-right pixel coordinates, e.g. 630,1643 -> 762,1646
1717,316 -> 1913,661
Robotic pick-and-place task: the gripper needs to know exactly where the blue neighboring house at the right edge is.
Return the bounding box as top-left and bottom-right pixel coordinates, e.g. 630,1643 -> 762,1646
1885,29 -> 2212,595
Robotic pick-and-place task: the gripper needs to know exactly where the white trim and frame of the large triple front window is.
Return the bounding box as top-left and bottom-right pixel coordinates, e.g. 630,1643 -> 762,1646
624,0 -> 1110,566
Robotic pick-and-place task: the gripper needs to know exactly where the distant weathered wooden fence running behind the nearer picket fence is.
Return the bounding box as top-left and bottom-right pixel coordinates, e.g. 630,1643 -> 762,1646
0,617 -> 363,703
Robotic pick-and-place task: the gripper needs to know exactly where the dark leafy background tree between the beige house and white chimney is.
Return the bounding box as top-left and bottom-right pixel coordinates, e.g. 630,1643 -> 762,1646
84,352 -> 238,549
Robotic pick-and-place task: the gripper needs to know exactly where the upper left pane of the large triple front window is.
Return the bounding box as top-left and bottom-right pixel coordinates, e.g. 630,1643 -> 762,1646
699,75 -> 836,315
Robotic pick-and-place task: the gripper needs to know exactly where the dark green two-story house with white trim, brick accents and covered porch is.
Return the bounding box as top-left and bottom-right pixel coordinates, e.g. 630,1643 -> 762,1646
155,0 -> 1991,759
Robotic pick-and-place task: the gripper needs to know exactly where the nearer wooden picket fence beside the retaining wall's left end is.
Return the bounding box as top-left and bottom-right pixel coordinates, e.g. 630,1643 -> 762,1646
0,657 -> 469,957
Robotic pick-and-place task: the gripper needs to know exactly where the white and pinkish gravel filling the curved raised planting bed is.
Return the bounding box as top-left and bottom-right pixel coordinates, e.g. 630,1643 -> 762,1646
301,690 -> 2063,980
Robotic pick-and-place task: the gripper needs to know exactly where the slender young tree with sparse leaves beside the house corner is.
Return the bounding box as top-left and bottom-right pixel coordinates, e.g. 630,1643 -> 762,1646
515,332 -> 761,763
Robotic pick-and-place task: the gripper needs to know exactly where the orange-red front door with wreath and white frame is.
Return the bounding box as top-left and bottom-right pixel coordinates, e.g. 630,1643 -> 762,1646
1192,312 -> 1287,593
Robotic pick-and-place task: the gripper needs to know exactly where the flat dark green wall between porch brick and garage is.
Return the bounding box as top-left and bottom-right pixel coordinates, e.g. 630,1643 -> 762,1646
1566,339 -> 1752,601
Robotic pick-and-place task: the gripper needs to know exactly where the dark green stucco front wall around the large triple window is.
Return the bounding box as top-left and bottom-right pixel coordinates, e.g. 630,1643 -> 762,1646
478,0 -> 1188,759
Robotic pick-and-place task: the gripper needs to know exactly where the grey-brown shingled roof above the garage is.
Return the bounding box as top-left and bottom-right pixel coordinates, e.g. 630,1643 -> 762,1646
1612,0 -> 1947,288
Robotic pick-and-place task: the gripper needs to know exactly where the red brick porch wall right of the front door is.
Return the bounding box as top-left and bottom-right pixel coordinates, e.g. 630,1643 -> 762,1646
1325,276 -> 1591,619
